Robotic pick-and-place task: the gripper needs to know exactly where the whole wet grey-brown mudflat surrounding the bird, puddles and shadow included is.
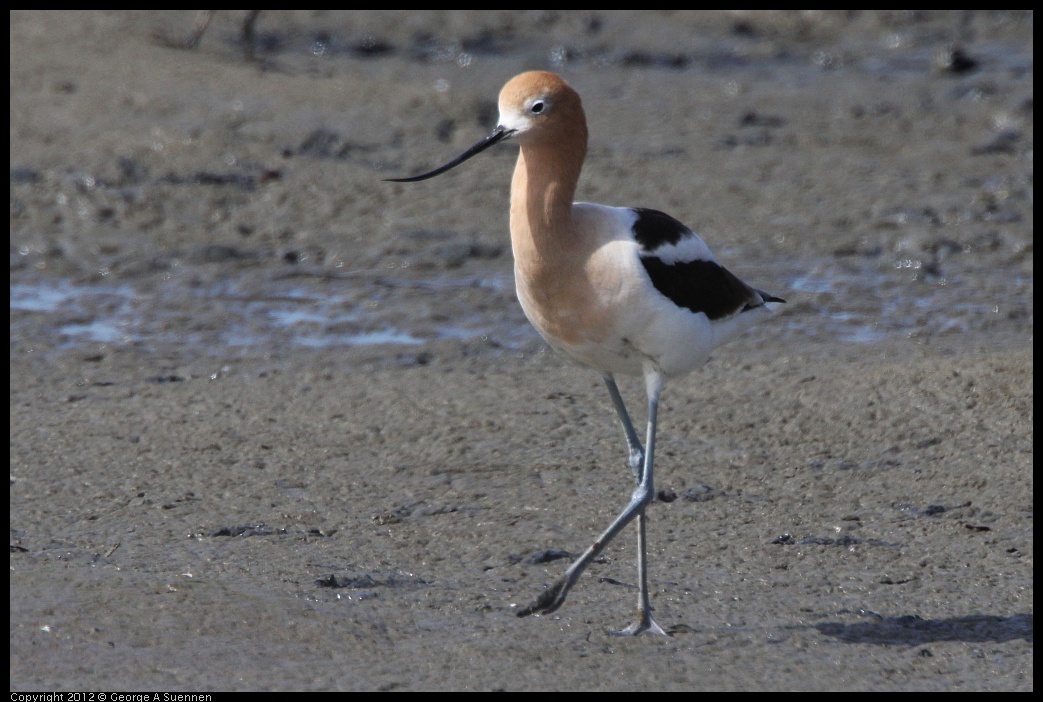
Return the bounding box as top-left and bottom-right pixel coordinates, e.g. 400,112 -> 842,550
9,10 -> 1034,693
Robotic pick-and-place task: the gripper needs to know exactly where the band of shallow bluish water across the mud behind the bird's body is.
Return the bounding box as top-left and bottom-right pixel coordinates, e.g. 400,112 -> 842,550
10,240 -> 1033,356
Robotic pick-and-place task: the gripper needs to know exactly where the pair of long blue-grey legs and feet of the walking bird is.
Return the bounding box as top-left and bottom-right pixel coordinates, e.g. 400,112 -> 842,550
517,371 -> 666,636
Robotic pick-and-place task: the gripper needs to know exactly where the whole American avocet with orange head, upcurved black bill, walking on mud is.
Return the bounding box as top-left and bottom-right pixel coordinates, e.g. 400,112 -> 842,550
389,71 -> 784,635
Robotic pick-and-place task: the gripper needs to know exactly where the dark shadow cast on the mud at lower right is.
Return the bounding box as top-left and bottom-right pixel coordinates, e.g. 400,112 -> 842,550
812,614 -> 1033,646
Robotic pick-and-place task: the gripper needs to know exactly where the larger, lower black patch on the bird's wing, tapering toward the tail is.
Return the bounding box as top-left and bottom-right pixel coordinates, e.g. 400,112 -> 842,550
640,256 -> 767,319
